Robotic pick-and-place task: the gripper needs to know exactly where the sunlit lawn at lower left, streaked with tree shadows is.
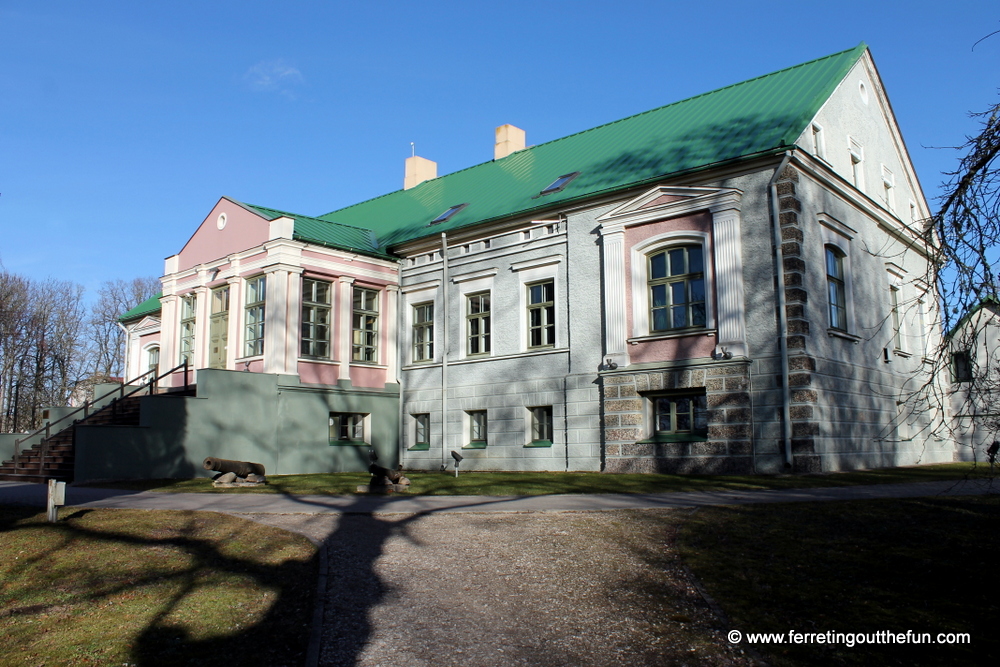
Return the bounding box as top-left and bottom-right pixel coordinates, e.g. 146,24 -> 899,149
0,507 -> 317,665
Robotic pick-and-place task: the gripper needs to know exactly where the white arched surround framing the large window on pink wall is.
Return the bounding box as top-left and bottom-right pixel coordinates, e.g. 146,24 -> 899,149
630,230 -> 716,338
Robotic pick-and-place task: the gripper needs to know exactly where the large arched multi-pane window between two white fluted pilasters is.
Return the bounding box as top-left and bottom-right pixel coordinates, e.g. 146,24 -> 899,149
647,245 -> 705,333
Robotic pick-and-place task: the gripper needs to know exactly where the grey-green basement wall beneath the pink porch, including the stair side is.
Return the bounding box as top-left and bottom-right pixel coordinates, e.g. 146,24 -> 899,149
75,369 -> 399,482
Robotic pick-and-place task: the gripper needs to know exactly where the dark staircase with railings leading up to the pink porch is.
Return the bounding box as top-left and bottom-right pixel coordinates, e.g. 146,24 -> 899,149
0,396 -> 145,483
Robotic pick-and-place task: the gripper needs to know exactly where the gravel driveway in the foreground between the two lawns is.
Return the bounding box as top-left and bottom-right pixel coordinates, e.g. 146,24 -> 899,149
244,510 -> 755,667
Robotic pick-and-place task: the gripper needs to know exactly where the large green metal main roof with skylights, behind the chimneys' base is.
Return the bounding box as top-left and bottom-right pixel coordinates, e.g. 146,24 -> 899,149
318,42 -> 868,248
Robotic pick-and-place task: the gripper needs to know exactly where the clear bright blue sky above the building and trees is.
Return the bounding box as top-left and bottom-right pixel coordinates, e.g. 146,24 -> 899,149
0,0 -> 1000,298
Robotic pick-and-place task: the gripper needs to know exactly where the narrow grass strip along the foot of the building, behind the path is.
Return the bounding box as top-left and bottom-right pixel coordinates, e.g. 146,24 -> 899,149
82,463 -> 990,496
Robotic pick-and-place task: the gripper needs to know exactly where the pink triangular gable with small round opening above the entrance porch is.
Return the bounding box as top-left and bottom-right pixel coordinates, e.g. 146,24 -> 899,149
178,198 -> 270,271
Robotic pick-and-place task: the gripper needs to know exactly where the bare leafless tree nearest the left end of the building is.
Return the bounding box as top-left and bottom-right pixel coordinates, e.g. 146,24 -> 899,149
89,277 -> 160,378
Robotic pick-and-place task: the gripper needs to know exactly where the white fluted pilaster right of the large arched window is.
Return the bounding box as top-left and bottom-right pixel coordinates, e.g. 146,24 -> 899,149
712,208 -> 747,357
